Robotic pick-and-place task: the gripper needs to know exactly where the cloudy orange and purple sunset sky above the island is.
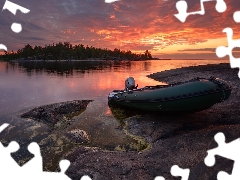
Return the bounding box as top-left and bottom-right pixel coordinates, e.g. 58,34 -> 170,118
0,0 -> 240,59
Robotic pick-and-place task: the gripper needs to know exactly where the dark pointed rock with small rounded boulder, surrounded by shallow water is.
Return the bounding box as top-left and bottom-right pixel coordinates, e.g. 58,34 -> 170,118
20,100 -> 91,144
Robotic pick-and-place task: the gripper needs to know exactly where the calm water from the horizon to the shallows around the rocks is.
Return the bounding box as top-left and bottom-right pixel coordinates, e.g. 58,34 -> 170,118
0,60 -> 228,169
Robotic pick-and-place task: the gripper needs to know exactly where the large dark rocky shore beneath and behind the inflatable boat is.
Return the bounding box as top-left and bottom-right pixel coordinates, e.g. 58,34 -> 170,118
64,64 -> 240,180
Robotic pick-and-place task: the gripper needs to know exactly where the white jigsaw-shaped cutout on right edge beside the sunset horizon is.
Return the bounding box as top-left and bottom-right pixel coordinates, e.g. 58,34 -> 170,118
216,28 -> 240,78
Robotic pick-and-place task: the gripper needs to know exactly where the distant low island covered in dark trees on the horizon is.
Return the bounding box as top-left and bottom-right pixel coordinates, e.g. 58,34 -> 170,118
0,42 -> 158,61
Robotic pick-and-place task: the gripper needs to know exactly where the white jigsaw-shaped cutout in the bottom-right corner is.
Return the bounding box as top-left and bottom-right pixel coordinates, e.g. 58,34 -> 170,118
204,133 -> 240,180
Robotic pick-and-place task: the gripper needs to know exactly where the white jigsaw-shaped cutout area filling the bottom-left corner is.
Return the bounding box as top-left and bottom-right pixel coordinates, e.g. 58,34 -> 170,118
0,123 -> 91,180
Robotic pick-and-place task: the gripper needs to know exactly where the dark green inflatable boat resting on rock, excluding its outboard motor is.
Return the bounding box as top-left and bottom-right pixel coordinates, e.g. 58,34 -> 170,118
108,77 -> 231,113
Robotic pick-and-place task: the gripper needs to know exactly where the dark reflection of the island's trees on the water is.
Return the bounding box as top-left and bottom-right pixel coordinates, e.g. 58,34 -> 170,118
9,60 -> 151,76
